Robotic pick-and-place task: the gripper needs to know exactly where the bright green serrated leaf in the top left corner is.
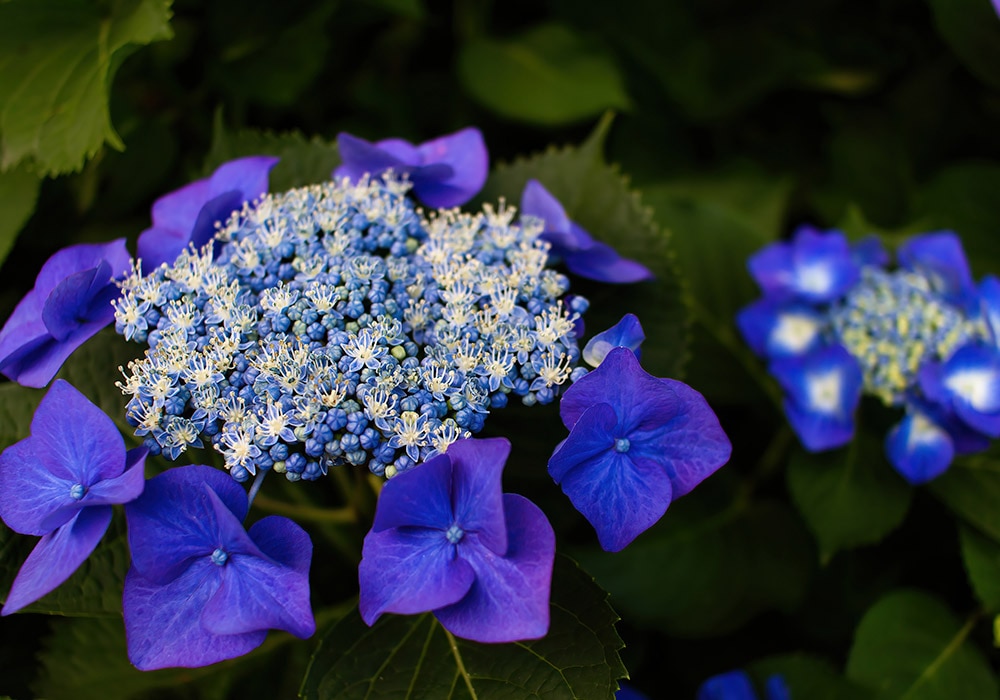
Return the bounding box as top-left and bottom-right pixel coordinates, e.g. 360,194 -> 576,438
0,0 -> 171,175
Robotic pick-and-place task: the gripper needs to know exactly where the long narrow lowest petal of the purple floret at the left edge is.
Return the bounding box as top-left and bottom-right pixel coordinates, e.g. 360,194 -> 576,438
0,506 -> 111,615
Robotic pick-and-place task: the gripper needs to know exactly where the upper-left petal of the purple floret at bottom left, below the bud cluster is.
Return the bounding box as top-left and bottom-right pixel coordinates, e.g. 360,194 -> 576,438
125,465 -> 248,584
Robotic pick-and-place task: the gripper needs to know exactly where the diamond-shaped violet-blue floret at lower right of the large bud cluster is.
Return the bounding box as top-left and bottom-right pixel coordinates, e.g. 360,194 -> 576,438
549,347 -> 732,552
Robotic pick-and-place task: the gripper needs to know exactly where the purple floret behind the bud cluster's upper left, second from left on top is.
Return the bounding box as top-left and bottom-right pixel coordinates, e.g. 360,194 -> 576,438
138,156 -> 278,271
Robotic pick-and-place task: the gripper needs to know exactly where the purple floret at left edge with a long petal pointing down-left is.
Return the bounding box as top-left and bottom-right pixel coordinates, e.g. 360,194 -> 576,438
0,379 -> 146,615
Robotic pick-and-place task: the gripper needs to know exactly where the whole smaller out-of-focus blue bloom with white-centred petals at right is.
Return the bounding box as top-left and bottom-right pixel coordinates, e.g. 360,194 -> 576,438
737,227 -> 1000,484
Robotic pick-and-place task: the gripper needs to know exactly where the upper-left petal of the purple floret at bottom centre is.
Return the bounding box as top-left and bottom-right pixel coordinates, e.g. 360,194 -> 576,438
372,455 -> 455,532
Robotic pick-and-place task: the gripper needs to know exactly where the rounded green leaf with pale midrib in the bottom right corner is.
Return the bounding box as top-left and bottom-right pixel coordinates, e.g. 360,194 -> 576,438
847,590 -> 998,700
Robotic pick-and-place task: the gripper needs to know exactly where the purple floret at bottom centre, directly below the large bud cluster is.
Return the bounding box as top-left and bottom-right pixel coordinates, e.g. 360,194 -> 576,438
358,438 -> 555,642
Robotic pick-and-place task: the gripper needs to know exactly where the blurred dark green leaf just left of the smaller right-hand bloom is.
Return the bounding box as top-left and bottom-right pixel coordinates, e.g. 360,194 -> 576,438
643,168 -> 790,403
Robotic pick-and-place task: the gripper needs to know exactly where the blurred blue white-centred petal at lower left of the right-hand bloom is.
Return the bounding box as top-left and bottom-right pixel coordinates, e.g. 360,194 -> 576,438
771,345 -> 862,452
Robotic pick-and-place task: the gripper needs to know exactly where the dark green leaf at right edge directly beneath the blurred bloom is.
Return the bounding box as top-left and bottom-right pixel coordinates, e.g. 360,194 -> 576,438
929,452 -> 1000,542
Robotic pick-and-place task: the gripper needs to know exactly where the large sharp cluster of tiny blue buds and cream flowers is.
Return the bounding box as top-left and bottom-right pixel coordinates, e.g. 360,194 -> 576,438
115,177 -> 587,481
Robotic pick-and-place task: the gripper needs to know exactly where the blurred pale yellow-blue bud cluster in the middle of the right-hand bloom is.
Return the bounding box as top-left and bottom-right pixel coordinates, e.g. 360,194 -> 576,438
830,267 -> 987,405
